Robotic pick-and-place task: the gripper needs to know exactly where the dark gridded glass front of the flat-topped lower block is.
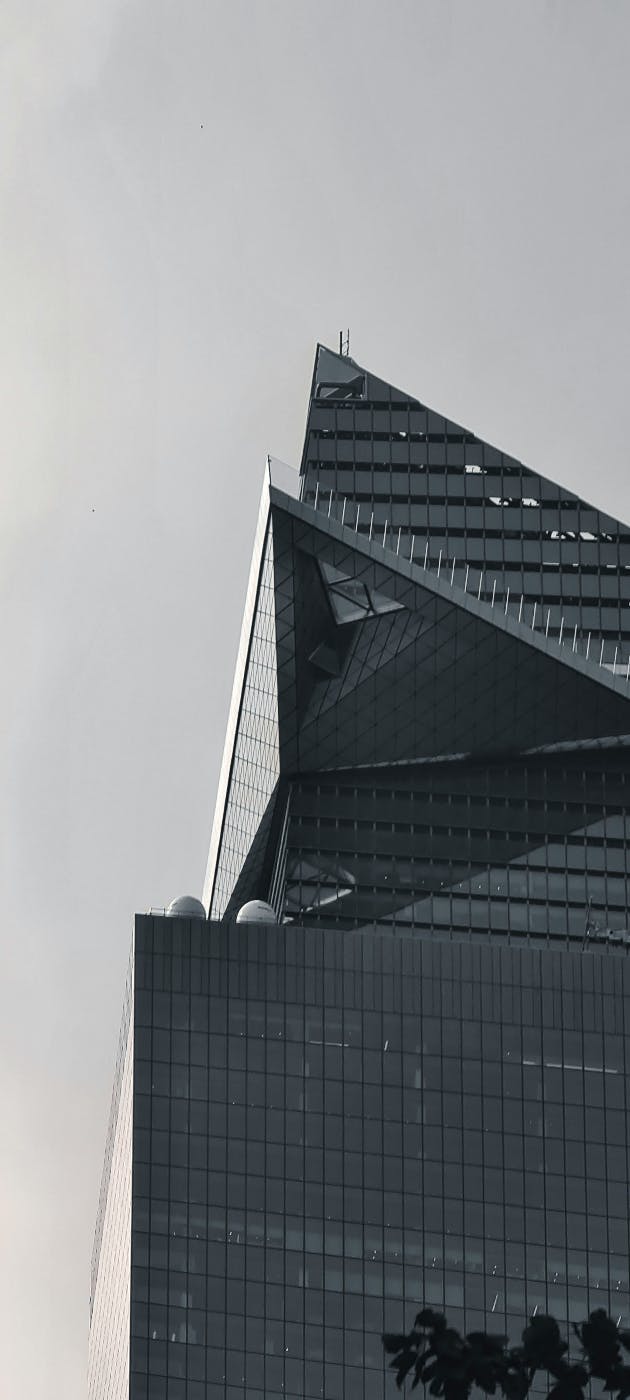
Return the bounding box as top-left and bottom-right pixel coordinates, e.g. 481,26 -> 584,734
130,918 -> 630,1400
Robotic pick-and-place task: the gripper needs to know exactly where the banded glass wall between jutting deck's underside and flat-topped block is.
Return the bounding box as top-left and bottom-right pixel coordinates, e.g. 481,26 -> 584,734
284,746 -> 630,939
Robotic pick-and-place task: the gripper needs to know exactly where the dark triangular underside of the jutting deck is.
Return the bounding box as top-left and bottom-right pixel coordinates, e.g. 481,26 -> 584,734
272,489 -> 630,773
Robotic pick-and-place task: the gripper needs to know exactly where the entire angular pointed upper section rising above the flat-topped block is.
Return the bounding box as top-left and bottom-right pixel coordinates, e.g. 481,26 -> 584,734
207,349 -> 630,939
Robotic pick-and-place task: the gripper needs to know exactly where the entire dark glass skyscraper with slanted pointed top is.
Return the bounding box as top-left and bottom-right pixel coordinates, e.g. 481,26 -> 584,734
90,347 -> 630,1400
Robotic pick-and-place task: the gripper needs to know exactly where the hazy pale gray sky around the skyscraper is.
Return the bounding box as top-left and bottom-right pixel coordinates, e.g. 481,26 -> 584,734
0,0 -> 630,1400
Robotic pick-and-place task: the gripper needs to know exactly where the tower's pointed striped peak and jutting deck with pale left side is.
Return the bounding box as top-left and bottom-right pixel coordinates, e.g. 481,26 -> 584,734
207,346 -> 630,911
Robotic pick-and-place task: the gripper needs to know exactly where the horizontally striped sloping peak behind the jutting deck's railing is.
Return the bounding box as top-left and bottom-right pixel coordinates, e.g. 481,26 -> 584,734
302,350 -> 630,665
